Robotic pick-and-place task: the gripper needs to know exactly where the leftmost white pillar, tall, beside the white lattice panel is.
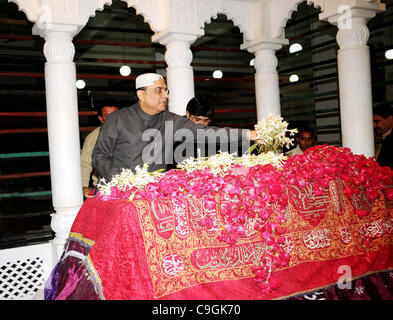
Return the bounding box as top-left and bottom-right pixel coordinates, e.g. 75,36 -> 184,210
38,26 -> 83,257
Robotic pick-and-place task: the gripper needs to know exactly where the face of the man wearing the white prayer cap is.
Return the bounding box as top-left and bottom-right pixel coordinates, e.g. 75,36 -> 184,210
138,79 -> 168,114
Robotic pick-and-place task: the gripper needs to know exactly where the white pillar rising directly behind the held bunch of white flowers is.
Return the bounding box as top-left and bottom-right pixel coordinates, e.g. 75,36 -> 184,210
241,39 -> 285,121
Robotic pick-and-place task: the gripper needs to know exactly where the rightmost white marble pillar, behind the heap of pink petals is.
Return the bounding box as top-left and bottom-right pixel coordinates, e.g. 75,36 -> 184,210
337,17 -> 375,157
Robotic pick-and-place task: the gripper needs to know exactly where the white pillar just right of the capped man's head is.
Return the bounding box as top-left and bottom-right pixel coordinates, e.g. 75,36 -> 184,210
155,32 -> 197,116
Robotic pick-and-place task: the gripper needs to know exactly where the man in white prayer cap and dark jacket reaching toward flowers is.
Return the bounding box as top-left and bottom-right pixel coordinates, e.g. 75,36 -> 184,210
93,73 -> 256,181
